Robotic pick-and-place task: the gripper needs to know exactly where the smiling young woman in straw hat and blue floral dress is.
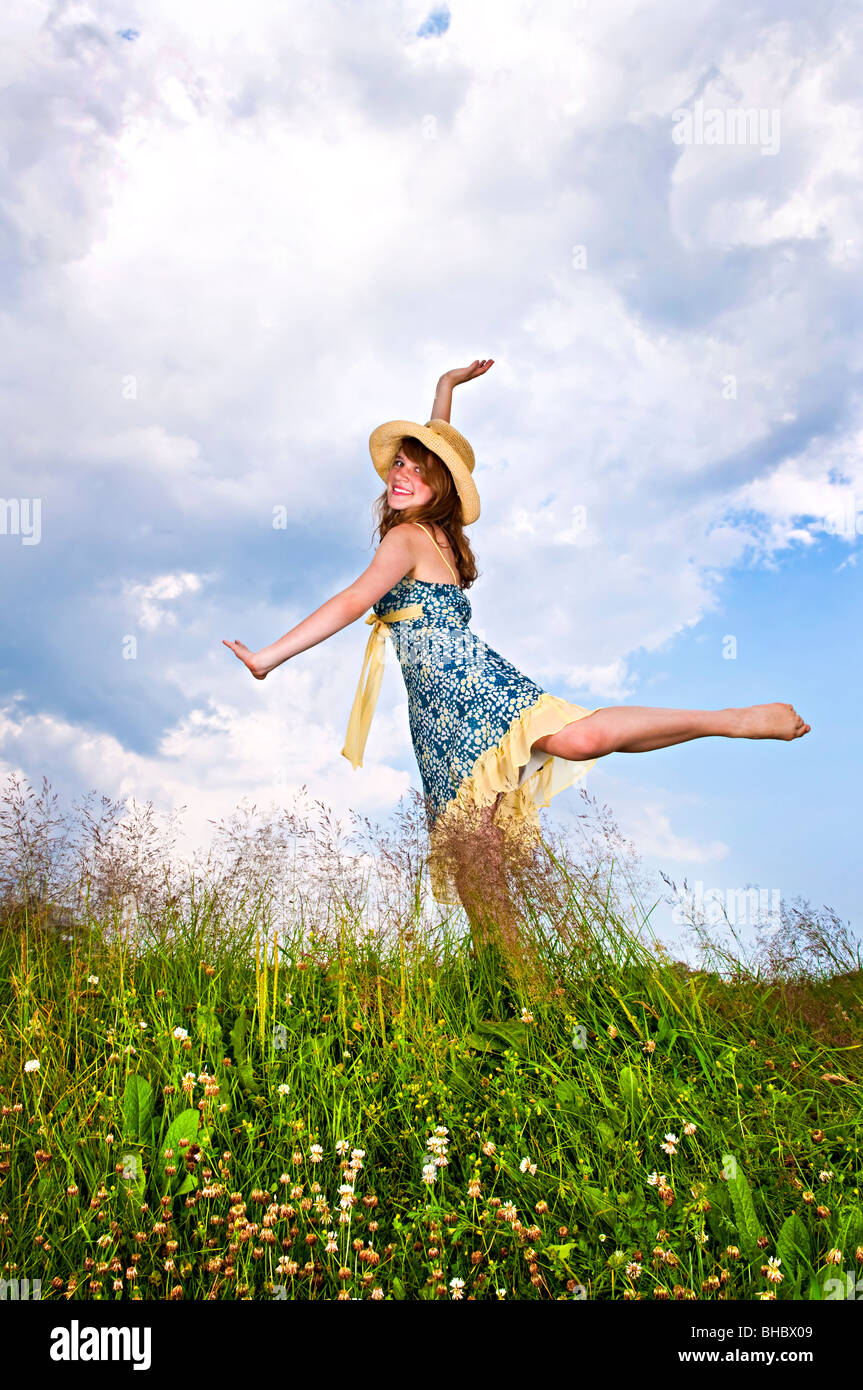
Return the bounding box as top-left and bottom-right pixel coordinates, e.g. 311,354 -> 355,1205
225,359 -> 810,902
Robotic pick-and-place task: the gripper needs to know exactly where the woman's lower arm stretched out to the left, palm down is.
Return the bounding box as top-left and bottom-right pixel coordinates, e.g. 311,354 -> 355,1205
222,525 -> 414,681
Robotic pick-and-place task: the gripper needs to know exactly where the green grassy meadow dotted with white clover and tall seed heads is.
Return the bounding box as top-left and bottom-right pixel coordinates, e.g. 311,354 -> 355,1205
0,781 -> 863,1301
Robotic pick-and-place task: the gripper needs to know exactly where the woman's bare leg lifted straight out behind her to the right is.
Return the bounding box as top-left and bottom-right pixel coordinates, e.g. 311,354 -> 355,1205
531,703 -> 812,762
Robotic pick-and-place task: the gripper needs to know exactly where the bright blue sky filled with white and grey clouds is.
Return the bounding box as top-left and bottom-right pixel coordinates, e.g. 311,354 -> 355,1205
0,0 -> 863,938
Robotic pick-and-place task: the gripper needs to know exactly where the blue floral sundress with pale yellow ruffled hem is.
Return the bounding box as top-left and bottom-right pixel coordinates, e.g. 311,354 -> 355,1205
343,521 -> 596,902
